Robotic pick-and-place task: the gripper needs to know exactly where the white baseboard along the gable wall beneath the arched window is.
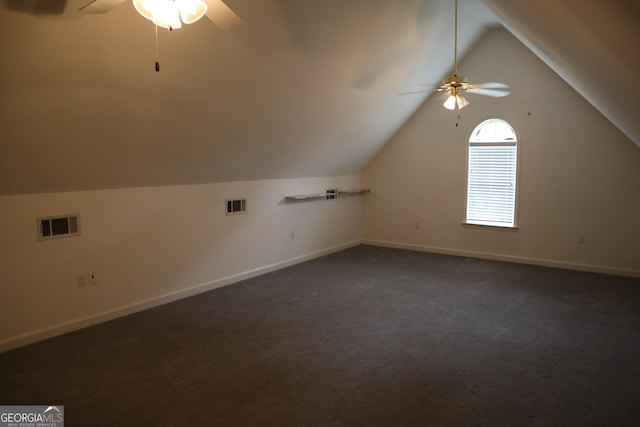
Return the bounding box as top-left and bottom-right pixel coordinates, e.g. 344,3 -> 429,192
361,239 -> 640,277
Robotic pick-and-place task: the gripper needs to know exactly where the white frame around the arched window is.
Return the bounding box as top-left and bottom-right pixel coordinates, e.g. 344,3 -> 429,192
462,117 -> 522,231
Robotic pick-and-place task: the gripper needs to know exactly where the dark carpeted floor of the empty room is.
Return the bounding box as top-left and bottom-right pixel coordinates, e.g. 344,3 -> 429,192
0,246 -> 640,427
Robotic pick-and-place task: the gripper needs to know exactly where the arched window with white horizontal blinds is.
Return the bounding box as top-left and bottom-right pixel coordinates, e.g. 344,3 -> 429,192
465,119 -> 518,228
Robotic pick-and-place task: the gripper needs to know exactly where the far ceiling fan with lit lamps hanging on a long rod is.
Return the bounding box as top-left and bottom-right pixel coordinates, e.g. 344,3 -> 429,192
404,0 -> 511,110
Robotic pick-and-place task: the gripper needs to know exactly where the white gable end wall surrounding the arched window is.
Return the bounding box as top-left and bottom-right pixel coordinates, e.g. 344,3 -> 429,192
364,30 -> 640,276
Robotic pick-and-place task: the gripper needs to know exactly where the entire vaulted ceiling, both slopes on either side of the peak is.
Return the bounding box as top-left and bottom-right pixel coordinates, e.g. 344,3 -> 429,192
0,0 -> 640,194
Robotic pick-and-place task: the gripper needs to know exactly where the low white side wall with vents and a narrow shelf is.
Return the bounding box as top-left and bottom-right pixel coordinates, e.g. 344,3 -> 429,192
0,176 -> 363,351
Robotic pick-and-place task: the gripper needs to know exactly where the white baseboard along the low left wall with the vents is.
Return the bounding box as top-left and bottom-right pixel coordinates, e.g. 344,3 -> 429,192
0,240 -> 360,353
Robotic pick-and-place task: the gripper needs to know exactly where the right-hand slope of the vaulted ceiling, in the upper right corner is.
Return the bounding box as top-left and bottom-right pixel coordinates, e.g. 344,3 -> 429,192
486,0 -> 640,152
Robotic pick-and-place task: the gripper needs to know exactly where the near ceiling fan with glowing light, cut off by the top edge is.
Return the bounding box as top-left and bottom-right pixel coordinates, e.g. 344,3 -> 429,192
80,0 -> 242,30
